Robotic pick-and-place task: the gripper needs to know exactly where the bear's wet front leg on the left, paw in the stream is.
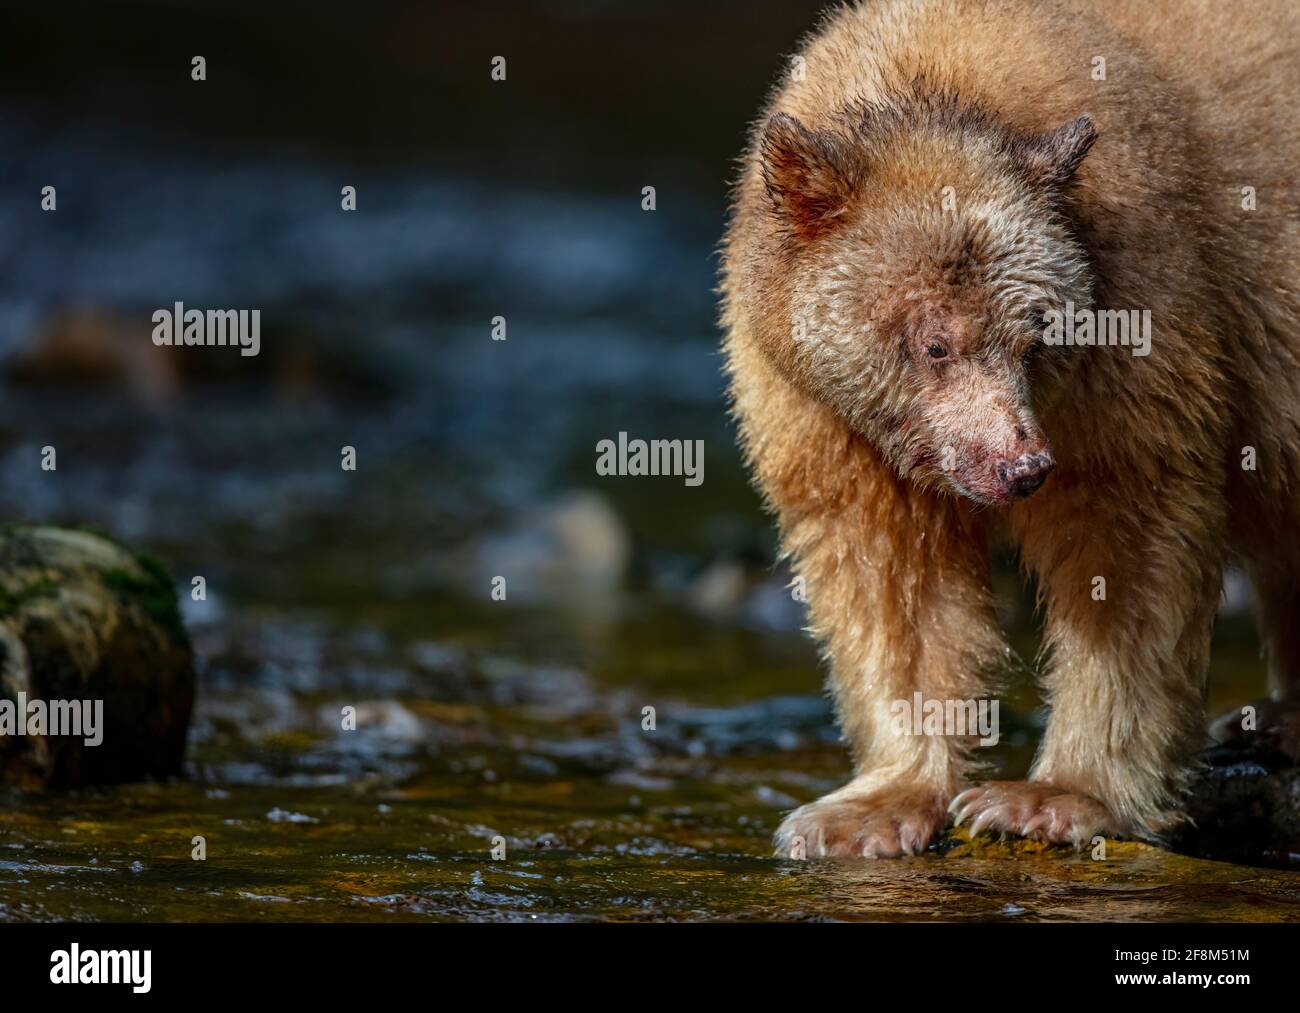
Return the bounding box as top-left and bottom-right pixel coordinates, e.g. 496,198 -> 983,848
770,438 -> 1006,858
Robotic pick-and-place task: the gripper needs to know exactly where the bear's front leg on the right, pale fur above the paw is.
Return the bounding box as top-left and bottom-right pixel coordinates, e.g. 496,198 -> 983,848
952,475 -> 1223,847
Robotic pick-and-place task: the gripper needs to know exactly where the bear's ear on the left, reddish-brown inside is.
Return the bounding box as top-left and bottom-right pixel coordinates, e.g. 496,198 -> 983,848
759,113 -> 858,238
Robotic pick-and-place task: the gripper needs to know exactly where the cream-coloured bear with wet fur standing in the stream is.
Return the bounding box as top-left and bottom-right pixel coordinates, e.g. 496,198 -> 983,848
720,0 -> 1300,857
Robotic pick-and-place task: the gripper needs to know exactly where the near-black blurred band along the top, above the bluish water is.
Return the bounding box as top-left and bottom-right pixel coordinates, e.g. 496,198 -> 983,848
0,0 -> 824,193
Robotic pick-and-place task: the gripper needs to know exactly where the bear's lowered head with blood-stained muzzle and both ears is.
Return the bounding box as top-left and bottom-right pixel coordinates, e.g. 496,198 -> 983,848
745,99 -> 1096,505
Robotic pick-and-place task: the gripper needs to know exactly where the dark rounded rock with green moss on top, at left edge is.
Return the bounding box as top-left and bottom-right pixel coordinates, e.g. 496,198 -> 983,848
0,528 -> 195,788
